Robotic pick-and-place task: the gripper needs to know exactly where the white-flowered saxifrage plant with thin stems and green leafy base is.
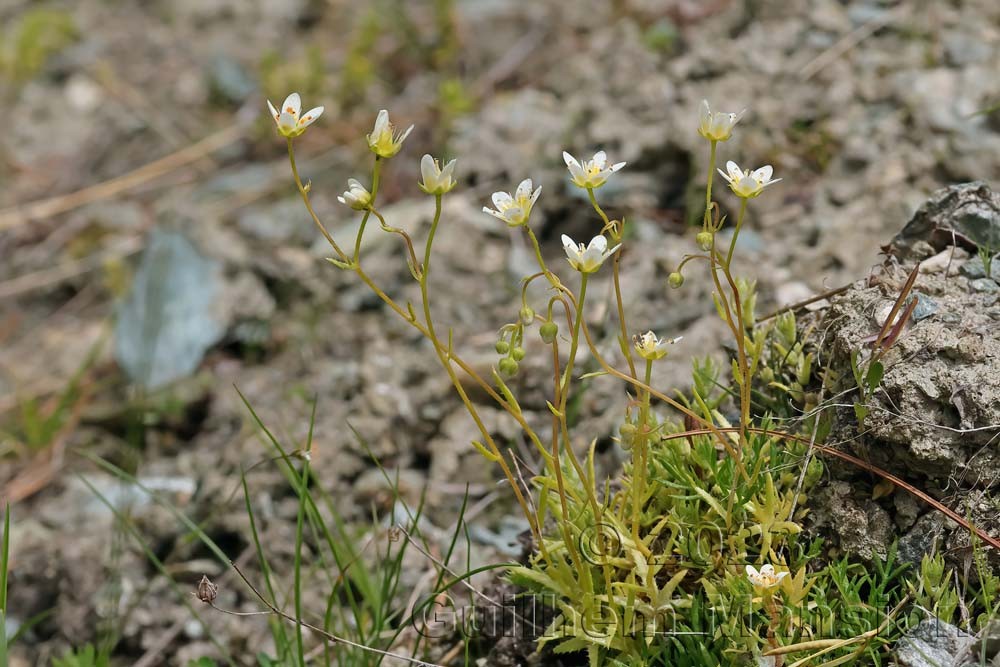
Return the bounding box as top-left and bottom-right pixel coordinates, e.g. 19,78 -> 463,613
244,93 -> 996,667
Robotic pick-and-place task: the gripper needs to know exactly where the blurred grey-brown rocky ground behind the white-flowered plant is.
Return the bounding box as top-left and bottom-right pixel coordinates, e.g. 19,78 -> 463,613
0,0 -> 1000,665
